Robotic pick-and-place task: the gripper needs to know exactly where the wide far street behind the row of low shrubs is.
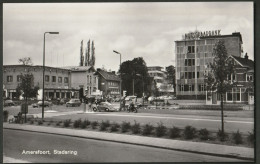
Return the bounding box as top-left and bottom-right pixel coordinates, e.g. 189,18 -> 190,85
3,106 -> 254,134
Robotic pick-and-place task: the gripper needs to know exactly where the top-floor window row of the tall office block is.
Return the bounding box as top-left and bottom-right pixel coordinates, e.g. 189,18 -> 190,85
177,45 -> 214,54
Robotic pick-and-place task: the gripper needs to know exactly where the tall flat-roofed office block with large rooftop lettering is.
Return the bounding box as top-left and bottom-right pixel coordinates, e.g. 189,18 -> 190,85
175,30 -> 243,99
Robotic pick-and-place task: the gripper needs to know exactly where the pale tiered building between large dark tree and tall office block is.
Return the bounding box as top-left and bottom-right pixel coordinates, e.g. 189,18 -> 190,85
147,66 -> 174,95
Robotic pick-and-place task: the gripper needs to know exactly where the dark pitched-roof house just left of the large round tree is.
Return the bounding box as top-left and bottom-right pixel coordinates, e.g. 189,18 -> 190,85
95,68 -> 120,97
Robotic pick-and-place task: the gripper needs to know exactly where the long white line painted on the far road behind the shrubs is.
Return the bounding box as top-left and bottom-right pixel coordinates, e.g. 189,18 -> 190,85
94,113 -> 254,124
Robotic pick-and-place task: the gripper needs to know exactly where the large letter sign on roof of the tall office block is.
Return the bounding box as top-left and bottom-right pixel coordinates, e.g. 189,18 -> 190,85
182,30 -> 220,40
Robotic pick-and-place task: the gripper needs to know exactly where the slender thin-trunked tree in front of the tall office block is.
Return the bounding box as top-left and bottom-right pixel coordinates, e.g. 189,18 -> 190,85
205,40 -> 235,134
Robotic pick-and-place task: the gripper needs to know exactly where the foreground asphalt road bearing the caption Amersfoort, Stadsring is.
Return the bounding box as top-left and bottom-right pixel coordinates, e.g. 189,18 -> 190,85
3,129 -> 248,163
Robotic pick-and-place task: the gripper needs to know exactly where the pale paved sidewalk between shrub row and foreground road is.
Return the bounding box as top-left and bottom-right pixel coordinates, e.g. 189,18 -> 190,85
3,123 -> 254,160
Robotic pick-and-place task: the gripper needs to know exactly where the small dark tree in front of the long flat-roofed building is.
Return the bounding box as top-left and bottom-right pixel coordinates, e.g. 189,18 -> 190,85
16,73 -> 39,122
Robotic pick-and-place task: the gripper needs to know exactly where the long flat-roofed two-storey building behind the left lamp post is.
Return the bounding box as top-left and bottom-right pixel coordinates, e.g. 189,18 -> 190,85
3,65 -> 74,99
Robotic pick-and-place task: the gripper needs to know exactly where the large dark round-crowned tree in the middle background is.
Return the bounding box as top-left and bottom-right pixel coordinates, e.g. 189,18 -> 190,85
119,57 -> 149,97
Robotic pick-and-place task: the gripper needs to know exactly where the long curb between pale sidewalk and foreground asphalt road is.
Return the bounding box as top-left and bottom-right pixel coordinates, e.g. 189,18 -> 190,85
3,124 -> 254,161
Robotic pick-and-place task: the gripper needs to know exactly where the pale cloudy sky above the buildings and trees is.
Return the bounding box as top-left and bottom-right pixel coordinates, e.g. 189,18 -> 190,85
3,2 -> 254,71
